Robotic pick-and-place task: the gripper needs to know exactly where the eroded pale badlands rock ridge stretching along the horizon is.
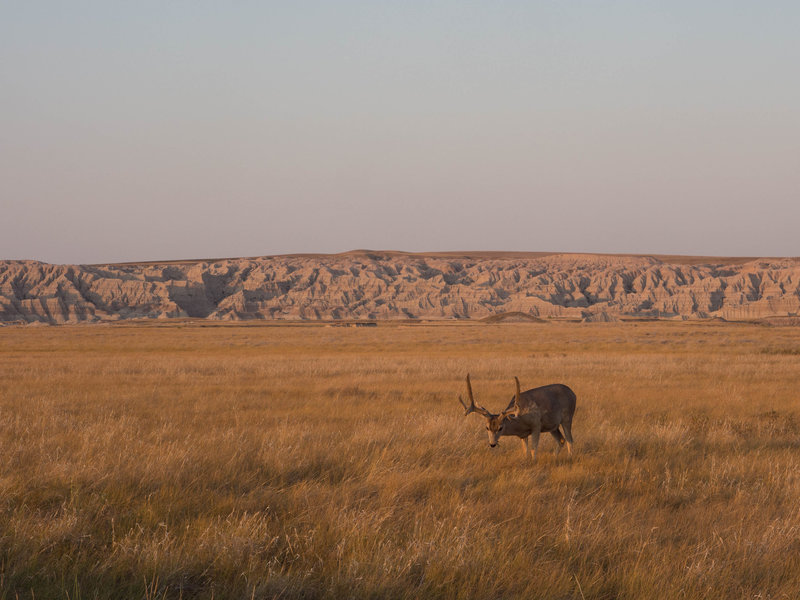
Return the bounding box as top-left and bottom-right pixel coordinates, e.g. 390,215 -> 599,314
0,251 -> 800,324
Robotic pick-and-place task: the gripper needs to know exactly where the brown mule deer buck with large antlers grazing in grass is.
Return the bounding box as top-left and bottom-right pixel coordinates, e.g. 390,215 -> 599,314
458,375 -> 576,461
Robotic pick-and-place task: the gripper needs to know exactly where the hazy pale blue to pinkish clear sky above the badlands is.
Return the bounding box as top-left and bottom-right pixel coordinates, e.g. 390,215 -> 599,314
0,0 -> 800,263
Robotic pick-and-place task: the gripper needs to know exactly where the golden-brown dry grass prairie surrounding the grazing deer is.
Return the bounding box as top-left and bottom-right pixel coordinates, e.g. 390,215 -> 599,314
0,322 -> 800,600
